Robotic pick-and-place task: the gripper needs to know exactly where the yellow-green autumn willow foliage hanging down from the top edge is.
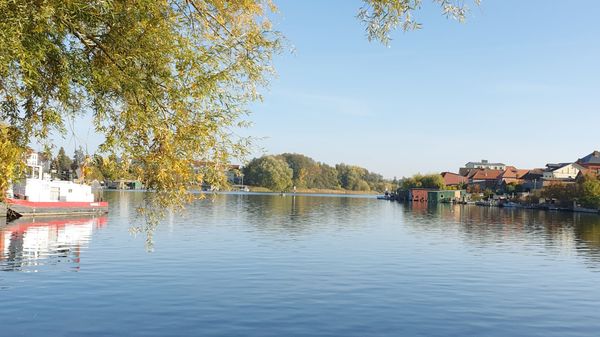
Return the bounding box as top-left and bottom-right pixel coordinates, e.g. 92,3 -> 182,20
0,0 -> 478,205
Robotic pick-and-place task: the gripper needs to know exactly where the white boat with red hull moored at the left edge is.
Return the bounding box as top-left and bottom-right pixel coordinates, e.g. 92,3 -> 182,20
5,155 -> 108,218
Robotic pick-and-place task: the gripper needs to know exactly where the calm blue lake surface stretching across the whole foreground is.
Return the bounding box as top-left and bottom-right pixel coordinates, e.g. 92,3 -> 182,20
0,192 -> 600,337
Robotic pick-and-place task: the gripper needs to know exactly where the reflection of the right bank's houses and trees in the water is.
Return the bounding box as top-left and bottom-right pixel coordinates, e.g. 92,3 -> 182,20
401,204 -> 600,268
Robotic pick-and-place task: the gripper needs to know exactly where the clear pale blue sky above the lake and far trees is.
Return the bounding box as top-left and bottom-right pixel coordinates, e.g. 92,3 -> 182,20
65,0 -> 600,178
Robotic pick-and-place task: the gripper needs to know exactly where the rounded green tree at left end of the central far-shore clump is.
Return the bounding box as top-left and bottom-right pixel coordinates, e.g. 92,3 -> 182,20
244,156 -> 293,191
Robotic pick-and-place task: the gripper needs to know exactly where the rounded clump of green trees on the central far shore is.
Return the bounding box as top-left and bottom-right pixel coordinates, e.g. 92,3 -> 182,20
243,153 -> 392,192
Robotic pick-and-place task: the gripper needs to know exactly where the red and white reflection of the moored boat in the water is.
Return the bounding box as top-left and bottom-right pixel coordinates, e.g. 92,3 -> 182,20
0,217 -> 107,271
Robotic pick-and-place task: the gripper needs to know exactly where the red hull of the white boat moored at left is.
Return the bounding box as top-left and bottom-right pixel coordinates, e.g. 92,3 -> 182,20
6,199 -> 108,216
